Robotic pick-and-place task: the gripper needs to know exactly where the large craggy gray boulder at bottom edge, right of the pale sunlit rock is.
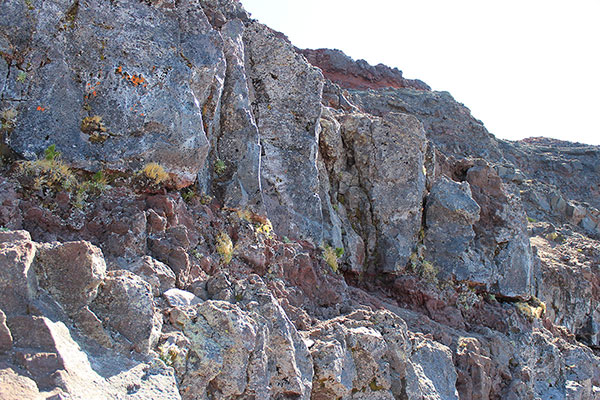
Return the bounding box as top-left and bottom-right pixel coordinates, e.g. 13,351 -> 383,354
166,276 -> 313,400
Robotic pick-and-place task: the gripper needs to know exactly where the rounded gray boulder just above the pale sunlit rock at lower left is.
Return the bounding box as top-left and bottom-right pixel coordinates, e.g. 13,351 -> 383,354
90,270 -> 162,354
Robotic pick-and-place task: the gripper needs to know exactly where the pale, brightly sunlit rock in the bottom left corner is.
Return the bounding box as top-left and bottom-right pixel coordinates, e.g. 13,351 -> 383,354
7,316 -> 181,400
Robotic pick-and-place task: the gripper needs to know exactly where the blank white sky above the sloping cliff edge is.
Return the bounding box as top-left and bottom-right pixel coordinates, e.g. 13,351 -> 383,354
241,0 -> 600,145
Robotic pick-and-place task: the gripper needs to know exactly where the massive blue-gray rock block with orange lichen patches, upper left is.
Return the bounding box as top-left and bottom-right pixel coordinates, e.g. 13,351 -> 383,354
0,0 -> 225,186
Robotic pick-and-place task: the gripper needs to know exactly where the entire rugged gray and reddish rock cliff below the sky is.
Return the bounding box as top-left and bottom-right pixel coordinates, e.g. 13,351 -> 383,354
0,0 -> 600,399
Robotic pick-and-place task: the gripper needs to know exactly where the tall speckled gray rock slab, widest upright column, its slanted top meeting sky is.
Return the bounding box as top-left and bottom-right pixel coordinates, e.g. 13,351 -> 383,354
244,22 -> 323,243
